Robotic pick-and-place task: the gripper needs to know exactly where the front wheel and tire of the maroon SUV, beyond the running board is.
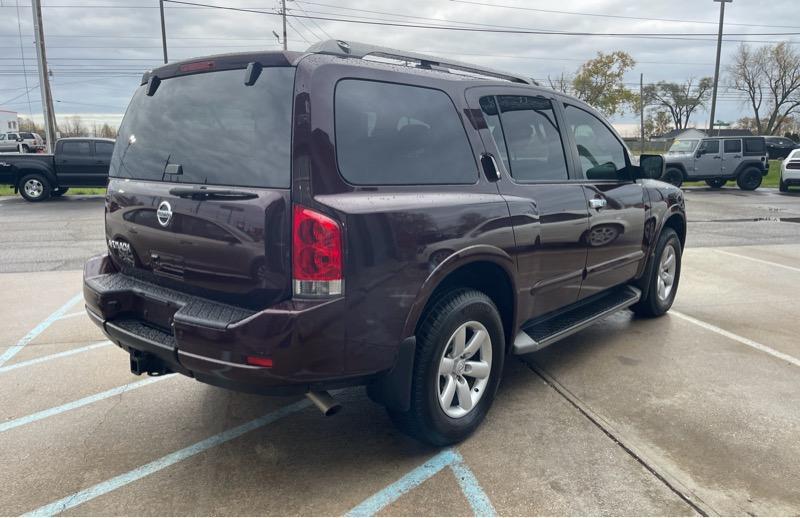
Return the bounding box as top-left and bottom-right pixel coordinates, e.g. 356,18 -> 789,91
631,227 -> 683,317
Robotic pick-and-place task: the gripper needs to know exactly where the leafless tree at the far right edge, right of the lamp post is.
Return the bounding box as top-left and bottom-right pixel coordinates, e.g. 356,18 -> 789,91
728,42 -> 800,135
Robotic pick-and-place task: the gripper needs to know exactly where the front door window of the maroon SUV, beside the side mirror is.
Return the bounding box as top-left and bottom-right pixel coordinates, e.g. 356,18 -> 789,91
566,106 -> 627,180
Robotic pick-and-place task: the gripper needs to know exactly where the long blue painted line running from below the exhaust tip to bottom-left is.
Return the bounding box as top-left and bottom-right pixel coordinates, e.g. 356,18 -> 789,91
24,399 -> 310,516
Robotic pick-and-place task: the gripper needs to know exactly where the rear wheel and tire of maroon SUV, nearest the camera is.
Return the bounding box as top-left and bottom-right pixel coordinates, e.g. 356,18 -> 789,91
388,289 -> 505,446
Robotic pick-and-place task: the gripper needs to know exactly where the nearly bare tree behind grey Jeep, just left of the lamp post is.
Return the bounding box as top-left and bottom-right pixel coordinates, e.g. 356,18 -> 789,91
643,77 -> 713,129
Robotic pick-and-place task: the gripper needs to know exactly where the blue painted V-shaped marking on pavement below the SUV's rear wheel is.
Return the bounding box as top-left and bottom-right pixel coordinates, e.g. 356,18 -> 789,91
347,448 -> 497,516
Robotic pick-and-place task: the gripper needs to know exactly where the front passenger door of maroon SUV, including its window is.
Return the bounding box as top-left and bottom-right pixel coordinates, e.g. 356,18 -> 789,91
564,103 -> 647,299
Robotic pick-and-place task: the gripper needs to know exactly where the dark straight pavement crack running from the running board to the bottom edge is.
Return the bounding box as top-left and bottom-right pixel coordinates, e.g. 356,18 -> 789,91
519,358 -> 719,516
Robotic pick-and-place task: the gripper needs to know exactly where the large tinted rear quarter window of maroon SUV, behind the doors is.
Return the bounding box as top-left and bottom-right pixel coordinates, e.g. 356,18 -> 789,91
334,79 -> 478,185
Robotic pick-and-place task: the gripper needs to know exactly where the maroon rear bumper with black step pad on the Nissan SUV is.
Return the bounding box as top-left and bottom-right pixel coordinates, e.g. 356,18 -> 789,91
83,255 -> 372,394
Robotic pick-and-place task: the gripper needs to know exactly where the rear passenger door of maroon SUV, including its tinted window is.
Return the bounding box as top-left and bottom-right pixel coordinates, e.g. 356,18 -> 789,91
467,87 -> 589,318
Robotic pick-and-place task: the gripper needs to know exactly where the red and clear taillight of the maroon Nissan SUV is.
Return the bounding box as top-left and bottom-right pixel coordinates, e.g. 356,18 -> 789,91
292,205 -> 344,297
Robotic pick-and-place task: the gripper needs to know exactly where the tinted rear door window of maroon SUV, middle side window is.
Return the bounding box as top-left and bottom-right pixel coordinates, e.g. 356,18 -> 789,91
481,95 -> 567,182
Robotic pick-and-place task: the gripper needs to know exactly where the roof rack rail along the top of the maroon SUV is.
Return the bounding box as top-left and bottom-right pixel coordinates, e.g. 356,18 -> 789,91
306,40 -> 538,85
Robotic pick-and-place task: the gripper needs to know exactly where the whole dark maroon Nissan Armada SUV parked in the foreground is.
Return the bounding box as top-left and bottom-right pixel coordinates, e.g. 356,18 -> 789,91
84,41 -> 686,444
